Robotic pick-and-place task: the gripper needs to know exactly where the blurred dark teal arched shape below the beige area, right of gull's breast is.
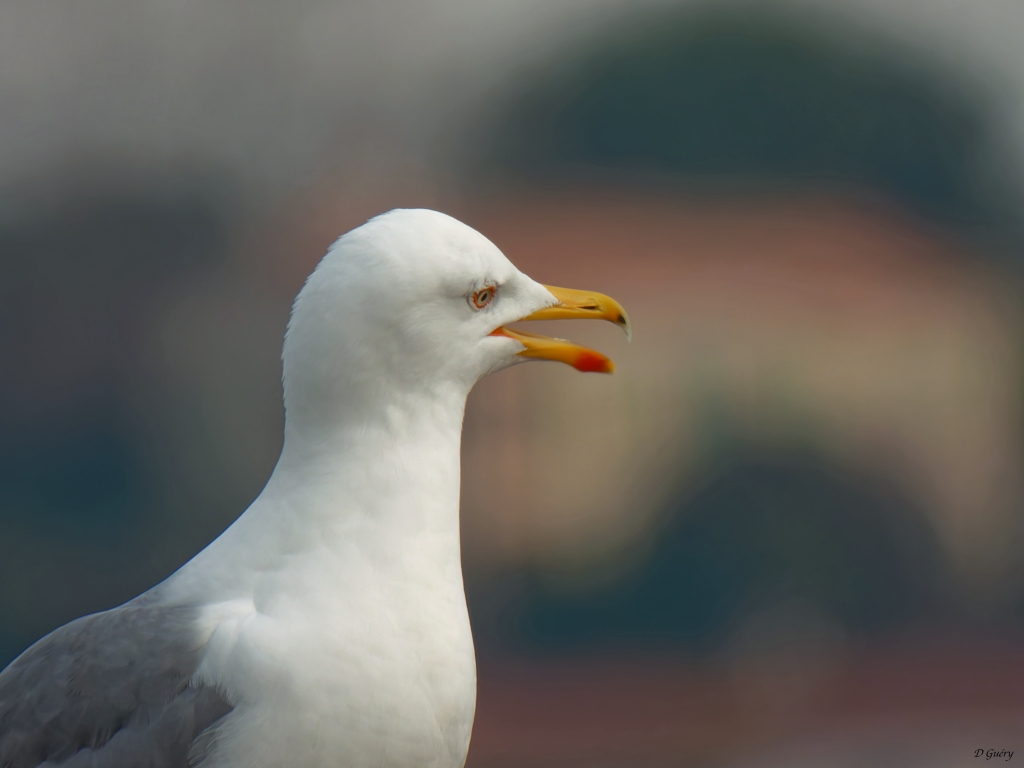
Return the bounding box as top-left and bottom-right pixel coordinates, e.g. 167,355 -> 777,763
471,456 -> 945,652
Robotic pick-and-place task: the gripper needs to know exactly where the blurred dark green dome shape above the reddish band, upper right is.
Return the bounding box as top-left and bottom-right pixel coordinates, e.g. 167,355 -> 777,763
483,7 -> 1019,240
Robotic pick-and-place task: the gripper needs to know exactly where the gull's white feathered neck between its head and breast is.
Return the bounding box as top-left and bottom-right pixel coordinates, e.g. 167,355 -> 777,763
168,385 -> 467,600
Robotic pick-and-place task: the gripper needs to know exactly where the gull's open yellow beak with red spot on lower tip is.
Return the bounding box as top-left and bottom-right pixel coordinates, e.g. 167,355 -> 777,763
490,286 -> 632,374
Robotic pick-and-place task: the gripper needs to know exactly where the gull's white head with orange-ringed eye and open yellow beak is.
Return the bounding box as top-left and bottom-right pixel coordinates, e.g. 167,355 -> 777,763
284,210 -> 630,430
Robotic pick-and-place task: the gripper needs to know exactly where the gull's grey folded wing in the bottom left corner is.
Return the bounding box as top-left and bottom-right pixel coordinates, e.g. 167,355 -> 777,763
0,595 -> 231,768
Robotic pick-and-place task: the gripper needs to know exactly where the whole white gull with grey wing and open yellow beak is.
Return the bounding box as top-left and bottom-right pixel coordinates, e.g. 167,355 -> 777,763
0,210 -> 630,768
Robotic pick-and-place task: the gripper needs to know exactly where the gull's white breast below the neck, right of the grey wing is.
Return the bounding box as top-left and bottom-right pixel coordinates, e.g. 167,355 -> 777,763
190,554 -> 476,768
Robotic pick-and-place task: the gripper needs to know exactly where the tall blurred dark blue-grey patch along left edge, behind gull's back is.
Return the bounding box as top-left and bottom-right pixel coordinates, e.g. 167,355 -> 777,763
0,178 -> 226,667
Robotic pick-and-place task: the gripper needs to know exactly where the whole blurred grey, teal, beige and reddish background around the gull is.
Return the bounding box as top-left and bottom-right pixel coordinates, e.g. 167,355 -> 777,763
0,0 -> 1024,768
